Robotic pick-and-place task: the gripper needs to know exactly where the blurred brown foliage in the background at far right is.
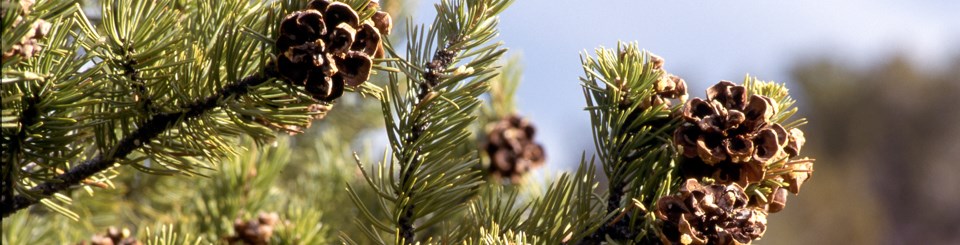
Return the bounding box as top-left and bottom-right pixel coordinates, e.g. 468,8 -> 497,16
761,53 -> 960,244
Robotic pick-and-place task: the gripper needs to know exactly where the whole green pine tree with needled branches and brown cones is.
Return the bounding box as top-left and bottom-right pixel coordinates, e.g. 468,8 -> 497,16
0,0 -> 813,244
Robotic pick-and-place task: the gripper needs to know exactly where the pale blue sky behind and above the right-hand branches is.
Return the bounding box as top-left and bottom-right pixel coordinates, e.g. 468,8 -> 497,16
416,0 -> 960,169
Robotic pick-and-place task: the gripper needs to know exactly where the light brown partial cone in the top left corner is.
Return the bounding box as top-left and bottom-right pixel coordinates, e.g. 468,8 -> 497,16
0,0 -> 51,61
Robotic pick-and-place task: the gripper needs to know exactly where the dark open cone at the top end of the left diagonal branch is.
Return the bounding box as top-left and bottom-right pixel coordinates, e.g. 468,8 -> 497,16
276,0 -> 389,102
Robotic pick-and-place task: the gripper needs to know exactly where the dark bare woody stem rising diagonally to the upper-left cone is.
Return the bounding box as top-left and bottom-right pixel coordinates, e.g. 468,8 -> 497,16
0,68 -> 273,217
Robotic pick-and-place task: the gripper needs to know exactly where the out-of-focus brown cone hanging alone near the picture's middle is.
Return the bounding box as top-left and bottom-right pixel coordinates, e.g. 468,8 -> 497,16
483,115 -> 546,182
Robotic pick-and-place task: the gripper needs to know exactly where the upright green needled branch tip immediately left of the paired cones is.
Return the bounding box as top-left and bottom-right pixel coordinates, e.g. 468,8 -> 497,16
581,43 -> 686,244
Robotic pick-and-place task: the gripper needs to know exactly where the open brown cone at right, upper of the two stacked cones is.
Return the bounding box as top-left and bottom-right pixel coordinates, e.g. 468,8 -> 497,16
673,81 -> 804,186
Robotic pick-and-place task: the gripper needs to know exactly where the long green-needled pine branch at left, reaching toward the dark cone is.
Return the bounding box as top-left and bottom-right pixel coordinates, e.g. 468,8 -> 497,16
0,0 -> 330,219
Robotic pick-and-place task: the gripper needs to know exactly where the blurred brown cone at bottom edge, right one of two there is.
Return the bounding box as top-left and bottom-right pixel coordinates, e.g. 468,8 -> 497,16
227,212 -> 280,245
